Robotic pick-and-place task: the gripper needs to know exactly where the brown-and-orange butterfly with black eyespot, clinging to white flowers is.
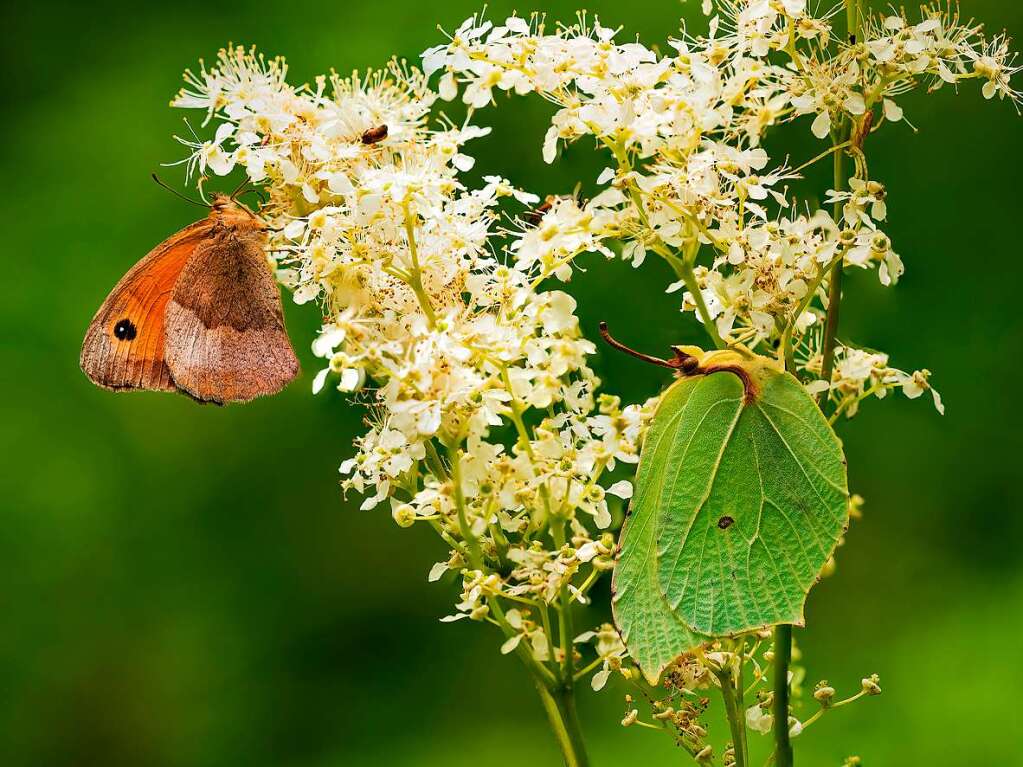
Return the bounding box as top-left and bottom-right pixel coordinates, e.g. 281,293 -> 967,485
80,195 -> 299,404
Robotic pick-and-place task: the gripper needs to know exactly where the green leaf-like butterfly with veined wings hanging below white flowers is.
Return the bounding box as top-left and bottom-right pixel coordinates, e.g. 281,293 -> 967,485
614,355 -> 848,681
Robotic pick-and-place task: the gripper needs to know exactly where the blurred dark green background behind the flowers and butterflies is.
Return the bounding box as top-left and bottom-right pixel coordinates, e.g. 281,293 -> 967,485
0,0 -> 1023,767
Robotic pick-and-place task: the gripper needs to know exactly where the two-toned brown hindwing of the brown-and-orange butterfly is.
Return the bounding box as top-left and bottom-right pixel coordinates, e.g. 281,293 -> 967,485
166,215 -> 299,402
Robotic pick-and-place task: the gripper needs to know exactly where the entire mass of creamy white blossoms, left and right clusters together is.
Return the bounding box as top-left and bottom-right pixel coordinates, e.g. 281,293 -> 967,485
173,0 -> 1020,695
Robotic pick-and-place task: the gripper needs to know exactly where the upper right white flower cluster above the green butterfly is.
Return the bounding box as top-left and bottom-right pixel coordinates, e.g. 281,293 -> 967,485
424,0 -> 1020,409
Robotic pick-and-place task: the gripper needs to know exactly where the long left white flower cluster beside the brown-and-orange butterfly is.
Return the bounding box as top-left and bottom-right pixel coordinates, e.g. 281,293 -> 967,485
174,48 -> 650,683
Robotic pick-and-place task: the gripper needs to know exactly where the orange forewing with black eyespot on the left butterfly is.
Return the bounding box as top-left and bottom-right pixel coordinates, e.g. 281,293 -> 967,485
79,219 -> 213,392
